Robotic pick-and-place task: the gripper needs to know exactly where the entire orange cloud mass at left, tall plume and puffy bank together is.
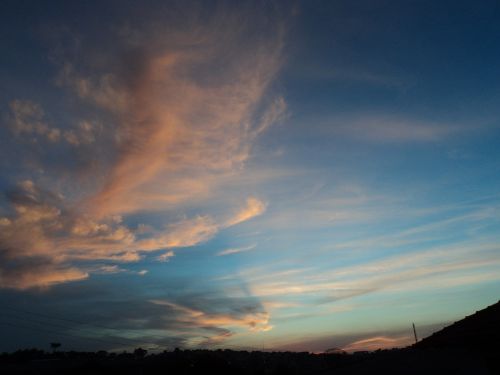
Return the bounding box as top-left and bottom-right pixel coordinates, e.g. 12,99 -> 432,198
0,5 -> 286,288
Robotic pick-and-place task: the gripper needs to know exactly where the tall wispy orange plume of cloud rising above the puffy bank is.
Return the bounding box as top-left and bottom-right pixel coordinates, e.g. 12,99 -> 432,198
63,20 -> 285,220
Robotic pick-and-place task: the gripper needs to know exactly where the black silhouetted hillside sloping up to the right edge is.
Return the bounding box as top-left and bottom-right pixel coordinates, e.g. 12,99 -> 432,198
330,302 -> 500,375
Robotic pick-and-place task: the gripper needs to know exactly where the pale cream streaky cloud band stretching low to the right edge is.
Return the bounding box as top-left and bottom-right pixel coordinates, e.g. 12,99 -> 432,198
239,235 -> 500,305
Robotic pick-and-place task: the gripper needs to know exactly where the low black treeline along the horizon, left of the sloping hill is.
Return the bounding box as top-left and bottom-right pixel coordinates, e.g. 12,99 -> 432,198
0,348 -> 363,375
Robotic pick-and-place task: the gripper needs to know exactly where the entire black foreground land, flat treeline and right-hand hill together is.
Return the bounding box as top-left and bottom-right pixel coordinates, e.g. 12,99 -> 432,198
0,302 -> 500,375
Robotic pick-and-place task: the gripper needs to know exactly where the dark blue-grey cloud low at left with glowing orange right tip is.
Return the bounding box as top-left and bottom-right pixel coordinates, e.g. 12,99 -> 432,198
0,279 -> 266,349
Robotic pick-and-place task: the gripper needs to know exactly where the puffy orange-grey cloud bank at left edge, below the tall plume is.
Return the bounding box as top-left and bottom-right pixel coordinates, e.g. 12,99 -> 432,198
0,180 -> 268,288
